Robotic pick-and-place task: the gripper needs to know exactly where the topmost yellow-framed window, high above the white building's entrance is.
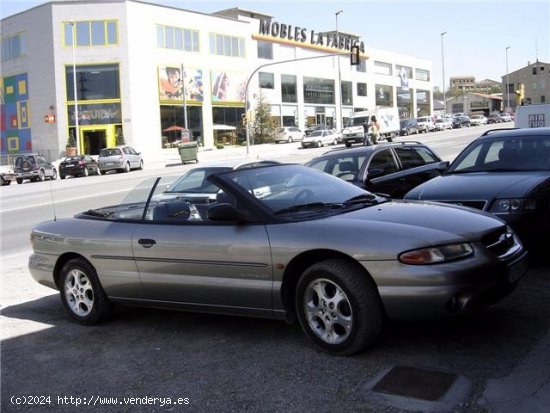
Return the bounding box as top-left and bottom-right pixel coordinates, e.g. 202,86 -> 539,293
63,20 -> 118,47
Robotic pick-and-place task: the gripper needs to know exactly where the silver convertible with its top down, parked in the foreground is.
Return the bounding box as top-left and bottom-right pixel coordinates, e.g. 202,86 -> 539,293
29,164 -> 527,355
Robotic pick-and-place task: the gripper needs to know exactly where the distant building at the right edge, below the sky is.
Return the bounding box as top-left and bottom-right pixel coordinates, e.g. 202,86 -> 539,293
502,60 -> 550,112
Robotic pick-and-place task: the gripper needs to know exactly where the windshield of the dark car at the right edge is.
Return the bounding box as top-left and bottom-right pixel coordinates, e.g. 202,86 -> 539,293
447,135 -> 550,174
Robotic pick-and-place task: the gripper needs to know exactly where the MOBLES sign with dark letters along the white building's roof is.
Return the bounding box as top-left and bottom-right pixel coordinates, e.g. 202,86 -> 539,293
259,20 -> 365,53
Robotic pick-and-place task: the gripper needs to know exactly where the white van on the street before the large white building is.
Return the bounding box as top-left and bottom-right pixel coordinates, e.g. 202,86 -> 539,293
342,108 -> 401,148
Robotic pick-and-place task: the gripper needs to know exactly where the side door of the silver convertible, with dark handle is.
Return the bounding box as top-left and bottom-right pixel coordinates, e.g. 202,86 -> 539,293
132,211 -> 273,313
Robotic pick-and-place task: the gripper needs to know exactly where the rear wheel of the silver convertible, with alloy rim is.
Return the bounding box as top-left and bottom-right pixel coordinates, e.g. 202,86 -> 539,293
59,258 -> 113,325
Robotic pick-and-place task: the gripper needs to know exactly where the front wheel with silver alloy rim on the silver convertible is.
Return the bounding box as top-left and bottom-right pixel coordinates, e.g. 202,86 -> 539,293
295,259 -> 384,356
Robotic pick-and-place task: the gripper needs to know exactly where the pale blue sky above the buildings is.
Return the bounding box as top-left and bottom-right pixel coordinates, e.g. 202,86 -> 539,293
0,0 -> 550,89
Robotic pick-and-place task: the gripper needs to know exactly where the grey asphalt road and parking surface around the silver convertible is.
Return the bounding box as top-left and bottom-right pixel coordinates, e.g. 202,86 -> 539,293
0,123 -> 550,413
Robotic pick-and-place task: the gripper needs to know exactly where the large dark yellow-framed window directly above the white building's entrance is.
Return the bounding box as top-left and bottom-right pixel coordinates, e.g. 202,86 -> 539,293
65,64 -> 120,101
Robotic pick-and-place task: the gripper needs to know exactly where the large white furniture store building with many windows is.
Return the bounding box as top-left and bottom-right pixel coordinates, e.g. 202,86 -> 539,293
0,0 -> 433,159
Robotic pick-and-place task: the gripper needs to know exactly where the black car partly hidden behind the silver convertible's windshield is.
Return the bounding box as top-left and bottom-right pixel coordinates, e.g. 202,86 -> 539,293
306,142 -> 449,198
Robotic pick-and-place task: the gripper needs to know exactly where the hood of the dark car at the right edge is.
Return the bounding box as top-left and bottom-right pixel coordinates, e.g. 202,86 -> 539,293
405,171 -> 550,201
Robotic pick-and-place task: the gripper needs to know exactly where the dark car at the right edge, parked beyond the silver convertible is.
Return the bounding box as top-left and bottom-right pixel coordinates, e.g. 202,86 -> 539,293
405,128 -> 550,247
